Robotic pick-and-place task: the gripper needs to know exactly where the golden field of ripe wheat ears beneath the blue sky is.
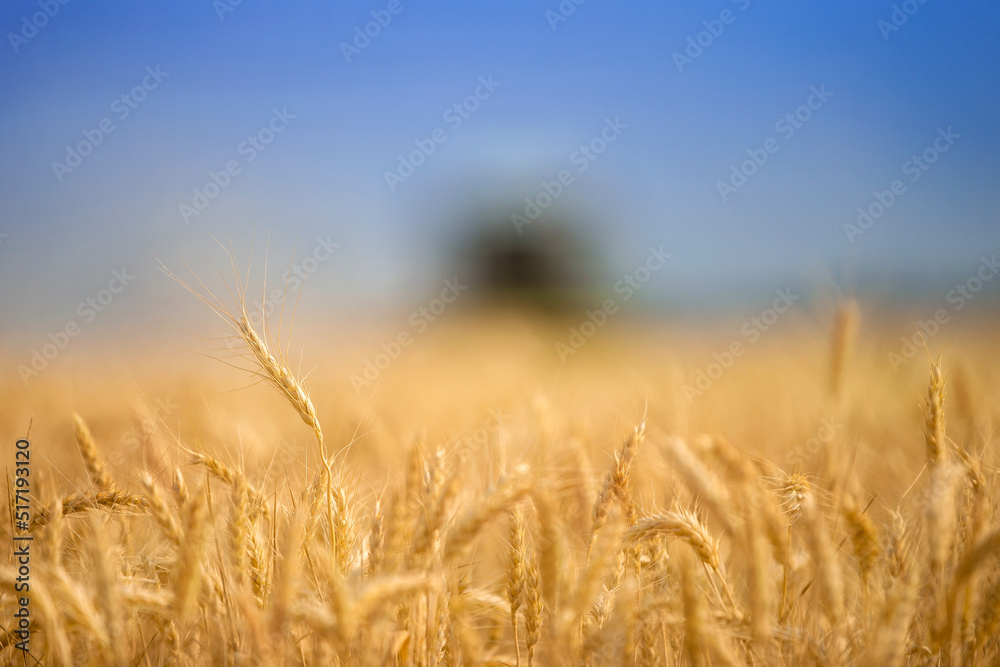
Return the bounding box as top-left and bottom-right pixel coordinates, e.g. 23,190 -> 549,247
0,276 -> 1000,666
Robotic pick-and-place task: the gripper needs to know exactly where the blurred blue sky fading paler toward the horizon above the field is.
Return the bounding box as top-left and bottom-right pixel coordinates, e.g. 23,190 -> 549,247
0,0 -> 1000,332
